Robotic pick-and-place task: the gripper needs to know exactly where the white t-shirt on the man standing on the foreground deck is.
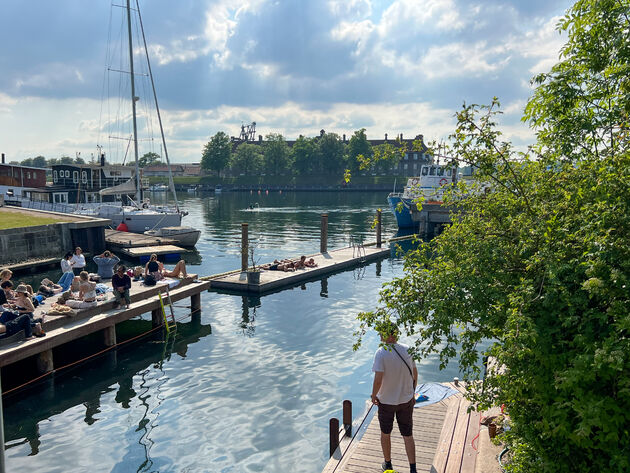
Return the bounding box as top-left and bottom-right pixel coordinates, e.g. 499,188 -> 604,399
372,343 -> 414,405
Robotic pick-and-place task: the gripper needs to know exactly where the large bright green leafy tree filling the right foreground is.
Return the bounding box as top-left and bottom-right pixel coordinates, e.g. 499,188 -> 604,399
358,0 -> 630,473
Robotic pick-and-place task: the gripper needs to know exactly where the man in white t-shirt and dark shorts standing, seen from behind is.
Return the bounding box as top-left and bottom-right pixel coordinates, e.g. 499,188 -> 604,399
372,322 -> 418,473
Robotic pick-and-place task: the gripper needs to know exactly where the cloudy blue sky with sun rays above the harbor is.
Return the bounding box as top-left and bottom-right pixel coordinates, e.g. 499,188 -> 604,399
0,0 -> 571,162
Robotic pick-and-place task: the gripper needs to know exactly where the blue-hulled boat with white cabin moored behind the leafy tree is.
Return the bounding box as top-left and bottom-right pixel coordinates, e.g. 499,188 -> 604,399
387,164 -> 457,228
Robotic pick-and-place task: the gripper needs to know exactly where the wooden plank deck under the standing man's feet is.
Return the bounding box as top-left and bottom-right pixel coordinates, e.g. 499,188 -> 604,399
323,383 -> 480,473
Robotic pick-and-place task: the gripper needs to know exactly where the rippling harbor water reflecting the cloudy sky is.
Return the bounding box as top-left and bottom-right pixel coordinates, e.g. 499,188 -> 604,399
3,192 -> 457,473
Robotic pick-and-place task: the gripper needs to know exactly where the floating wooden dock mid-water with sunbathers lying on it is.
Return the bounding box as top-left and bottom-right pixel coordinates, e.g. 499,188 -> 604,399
210,246 -> 390,294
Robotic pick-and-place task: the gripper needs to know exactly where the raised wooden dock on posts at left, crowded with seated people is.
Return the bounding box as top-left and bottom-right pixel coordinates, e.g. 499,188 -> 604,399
0,275 -> 210,373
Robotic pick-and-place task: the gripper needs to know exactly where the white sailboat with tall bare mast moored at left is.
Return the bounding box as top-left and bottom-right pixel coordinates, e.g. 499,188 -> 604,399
77,0 -> 187,233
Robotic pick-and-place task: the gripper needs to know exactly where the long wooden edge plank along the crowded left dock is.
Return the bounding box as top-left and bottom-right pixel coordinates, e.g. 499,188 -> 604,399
0,282 -> 210,367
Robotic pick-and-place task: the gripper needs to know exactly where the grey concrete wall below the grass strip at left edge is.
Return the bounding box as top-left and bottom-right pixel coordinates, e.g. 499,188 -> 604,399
0,223 -> 72,265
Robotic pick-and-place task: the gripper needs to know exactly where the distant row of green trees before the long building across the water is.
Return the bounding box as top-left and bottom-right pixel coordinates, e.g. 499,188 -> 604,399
201,128 -> 414,176
